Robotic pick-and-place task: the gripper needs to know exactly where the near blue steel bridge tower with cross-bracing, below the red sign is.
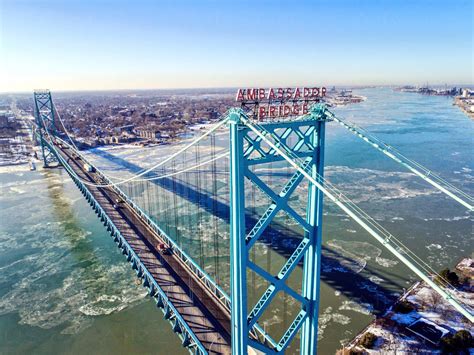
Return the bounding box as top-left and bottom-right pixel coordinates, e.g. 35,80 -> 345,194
228,104 -> 329,355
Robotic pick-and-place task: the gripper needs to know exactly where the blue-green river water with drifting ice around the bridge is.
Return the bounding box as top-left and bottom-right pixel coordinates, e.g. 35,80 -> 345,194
0,89 -> 474,354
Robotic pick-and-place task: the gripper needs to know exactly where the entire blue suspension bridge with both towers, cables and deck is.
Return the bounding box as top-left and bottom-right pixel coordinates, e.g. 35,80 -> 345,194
34,89 -> 474,355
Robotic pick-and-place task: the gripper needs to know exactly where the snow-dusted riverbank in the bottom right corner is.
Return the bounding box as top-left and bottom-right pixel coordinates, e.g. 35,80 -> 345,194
338,258 -> 474,354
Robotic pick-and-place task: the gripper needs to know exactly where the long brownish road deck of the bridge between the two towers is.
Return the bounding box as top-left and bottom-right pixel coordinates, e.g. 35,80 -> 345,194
57,146 -> 230,354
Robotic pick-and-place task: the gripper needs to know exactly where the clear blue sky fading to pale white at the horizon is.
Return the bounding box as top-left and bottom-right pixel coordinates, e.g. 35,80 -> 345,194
0,0 -> 473,91
